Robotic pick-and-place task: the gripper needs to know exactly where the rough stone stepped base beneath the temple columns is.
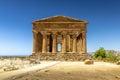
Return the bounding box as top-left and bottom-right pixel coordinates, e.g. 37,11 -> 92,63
31,53 -> 90,61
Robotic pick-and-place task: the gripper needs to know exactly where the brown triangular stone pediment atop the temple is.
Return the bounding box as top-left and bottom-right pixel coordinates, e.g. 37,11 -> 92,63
34,16 -> 87,23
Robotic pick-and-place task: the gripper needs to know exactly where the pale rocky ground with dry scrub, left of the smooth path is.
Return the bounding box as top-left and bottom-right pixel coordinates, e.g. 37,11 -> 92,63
0,58 -> 36,73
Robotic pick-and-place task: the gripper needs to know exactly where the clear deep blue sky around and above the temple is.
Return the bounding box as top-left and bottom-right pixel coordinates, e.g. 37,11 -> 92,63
0,0 -> 120,55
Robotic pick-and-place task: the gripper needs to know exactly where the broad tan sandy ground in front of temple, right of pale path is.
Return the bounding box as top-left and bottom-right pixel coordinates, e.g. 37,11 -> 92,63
9,62 -> 120,80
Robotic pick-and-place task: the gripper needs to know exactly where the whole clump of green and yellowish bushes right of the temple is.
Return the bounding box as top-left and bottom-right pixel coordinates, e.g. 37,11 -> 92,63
93,47 -> 120,65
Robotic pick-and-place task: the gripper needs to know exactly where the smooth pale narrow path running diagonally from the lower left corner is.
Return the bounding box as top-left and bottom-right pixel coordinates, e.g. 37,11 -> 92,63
0,61 -> 58,80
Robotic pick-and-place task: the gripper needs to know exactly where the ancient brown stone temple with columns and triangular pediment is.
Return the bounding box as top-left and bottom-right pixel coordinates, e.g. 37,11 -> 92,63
32,16 -> 87,60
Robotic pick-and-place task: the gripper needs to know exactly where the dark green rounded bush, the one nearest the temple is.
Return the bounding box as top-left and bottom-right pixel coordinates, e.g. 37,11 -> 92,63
93,47 -> 106,59
